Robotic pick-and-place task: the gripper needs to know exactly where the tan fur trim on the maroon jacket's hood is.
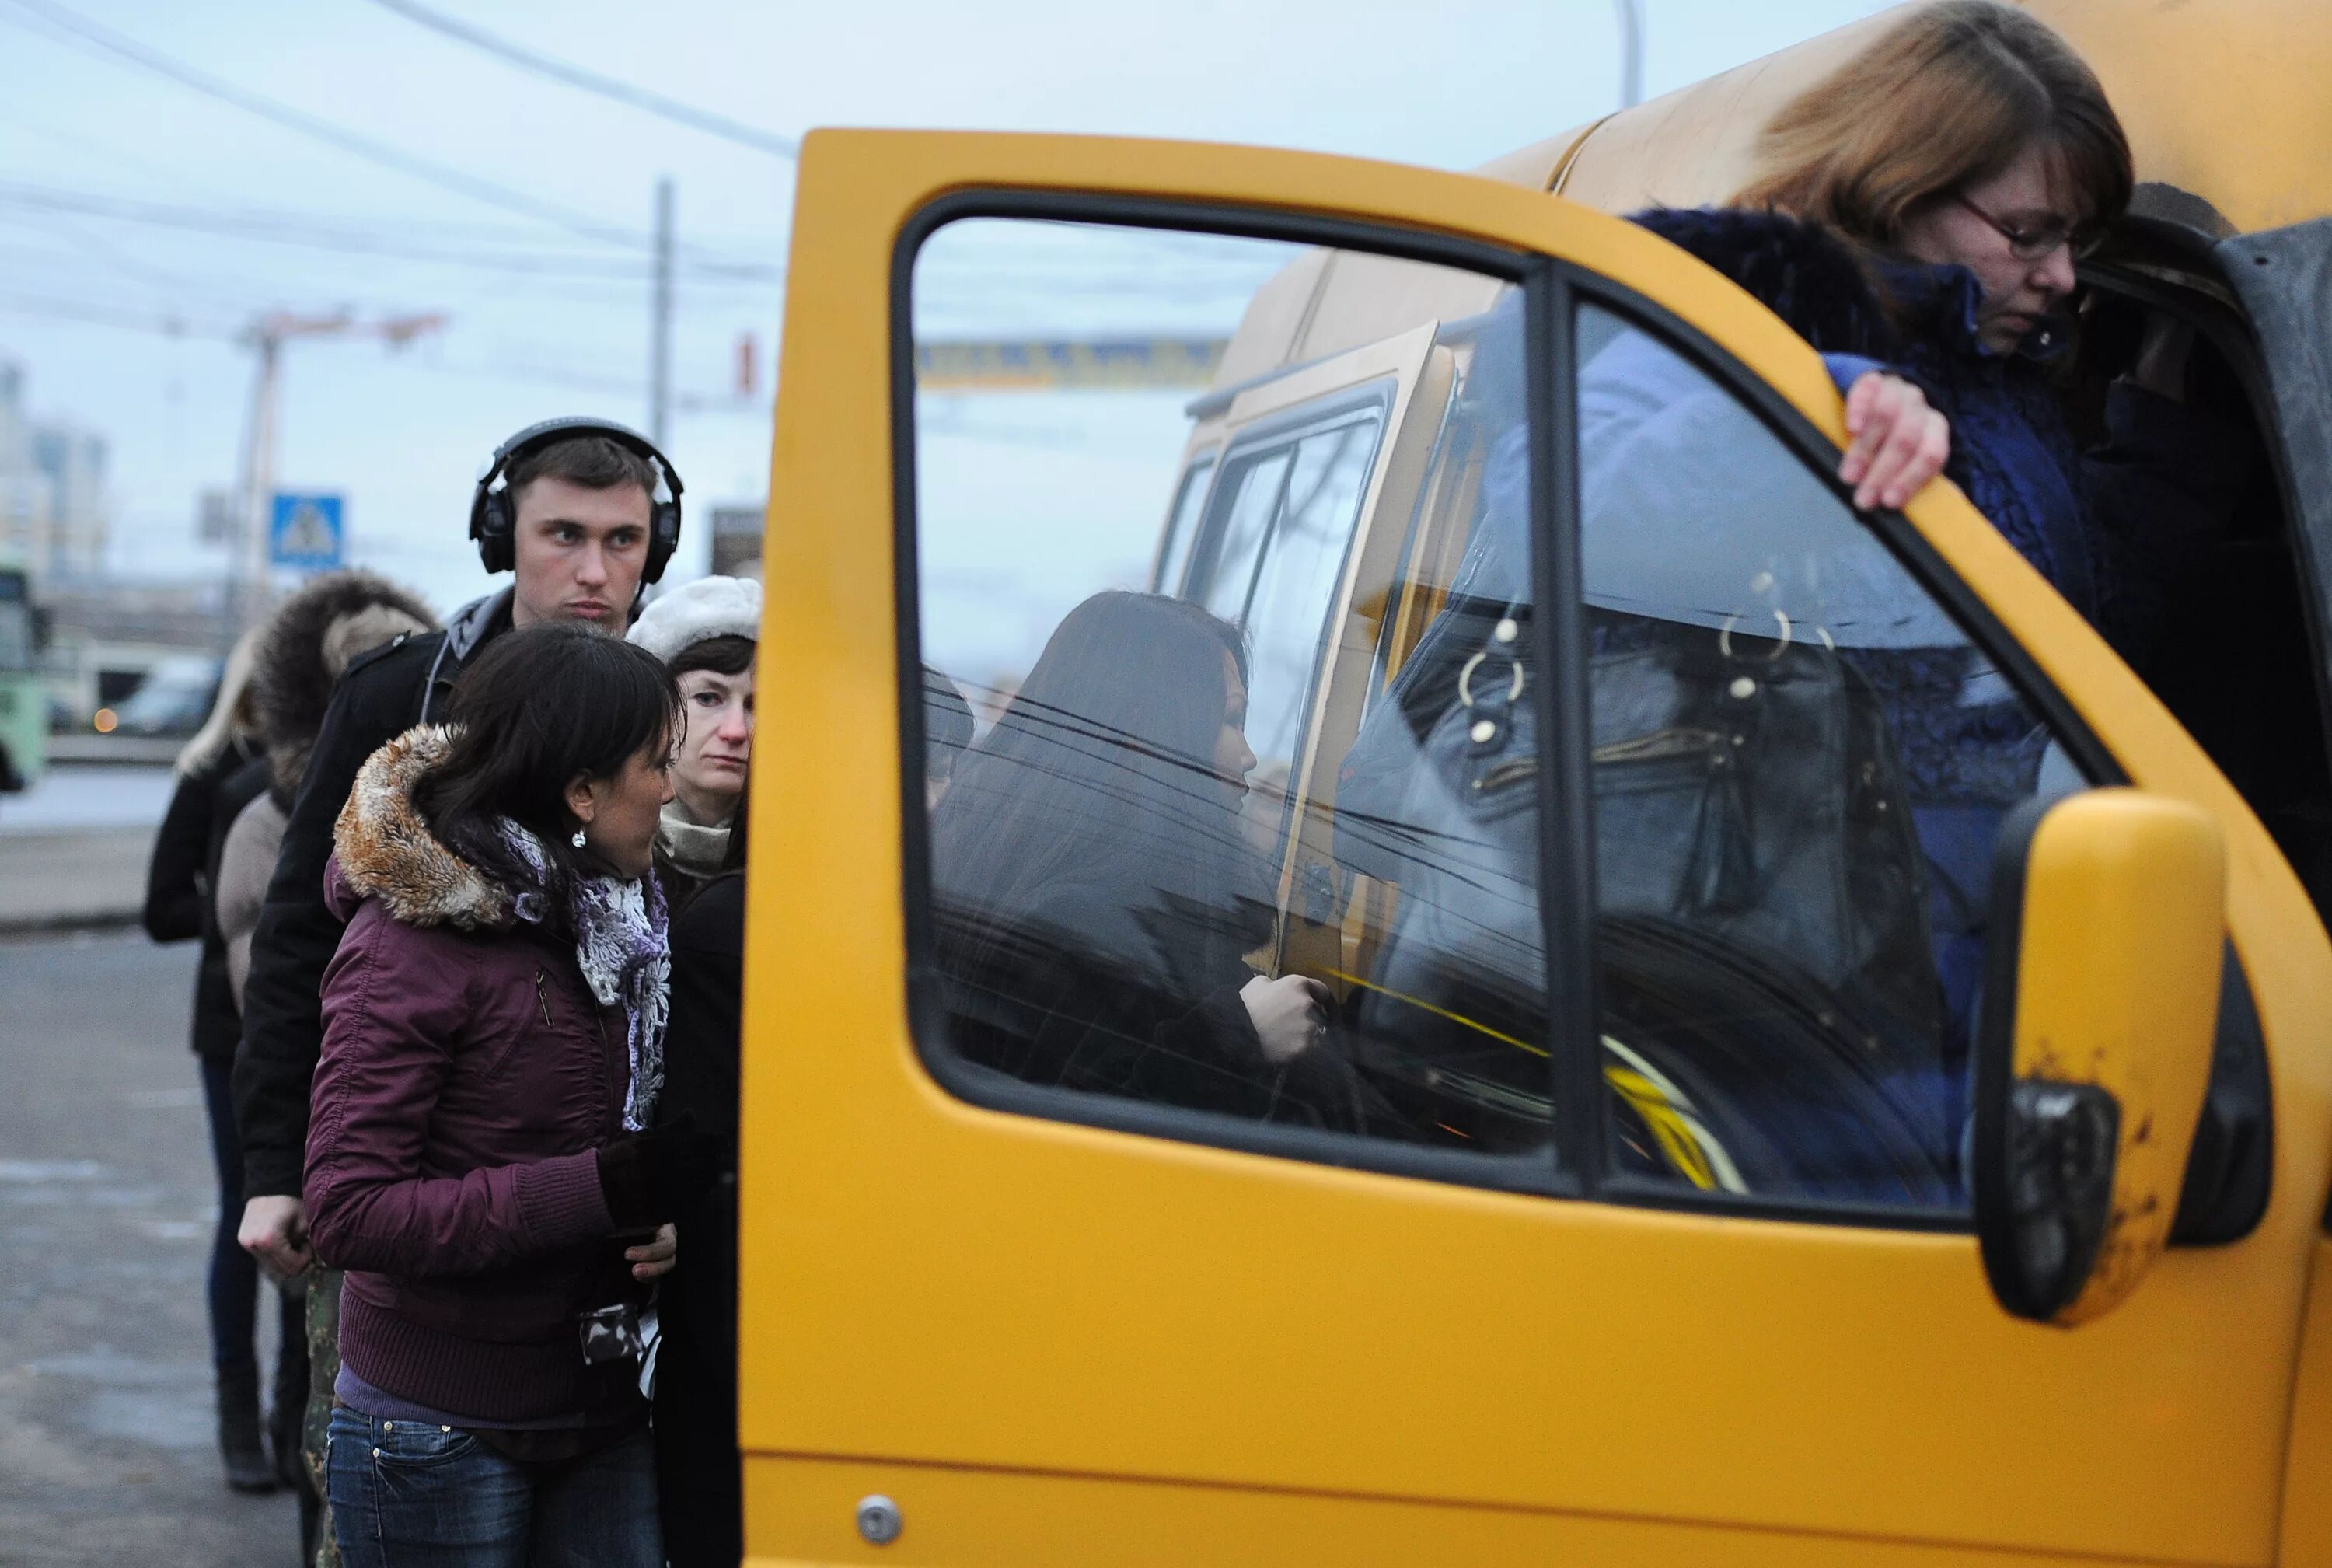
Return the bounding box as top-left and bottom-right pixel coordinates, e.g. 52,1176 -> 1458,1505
326,723 -> 513,931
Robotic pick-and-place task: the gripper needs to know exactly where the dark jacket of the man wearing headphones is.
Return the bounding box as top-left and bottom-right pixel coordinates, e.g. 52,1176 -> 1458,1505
236,588 -> 511,1197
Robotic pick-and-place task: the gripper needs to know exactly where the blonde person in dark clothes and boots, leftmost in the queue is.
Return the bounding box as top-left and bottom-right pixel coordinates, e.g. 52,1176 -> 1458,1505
145,627 -> 292,1491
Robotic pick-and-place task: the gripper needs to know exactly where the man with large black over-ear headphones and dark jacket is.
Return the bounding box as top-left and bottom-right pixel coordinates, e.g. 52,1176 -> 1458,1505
236,417 -> 681,1276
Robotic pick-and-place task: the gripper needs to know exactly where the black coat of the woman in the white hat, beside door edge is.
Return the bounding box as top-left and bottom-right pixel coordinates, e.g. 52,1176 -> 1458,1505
655,873 -> 744,1568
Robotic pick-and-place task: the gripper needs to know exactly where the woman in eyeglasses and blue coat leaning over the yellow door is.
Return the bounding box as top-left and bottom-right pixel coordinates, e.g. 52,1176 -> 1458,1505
1635,0 -> 2257,1125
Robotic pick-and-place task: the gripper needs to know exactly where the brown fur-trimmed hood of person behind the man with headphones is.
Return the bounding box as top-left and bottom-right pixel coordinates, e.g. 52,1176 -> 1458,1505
252,571 -> 436,810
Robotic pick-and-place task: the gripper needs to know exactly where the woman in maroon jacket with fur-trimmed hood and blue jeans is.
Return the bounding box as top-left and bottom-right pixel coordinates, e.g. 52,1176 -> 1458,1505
305,625 -> 690,1568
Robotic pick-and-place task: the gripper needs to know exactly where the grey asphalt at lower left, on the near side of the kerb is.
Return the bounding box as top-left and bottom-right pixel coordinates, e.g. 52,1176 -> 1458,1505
0,931 -> 298,1568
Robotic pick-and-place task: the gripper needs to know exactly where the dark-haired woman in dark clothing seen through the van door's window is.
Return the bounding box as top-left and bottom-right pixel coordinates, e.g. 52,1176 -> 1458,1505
930,592 -> 1360,1127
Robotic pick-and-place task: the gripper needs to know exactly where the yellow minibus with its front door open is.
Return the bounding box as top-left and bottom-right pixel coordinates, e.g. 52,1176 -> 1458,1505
739,0 -> 2332,1566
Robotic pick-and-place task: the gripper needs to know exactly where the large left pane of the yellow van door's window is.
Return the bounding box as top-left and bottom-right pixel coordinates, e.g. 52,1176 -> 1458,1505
907,219 -> 1551,1186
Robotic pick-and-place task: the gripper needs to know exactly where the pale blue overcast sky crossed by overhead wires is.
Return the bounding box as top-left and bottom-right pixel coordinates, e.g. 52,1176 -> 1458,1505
0,0 -> 1880,604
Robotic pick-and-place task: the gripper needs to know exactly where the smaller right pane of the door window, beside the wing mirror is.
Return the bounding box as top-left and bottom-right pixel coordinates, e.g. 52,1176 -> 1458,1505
1576,306 -> 2082,1209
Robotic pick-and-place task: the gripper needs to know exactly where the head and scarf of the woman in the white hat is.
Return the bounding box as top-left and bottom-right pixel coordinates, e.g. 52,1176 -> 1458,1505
627,576 -> 760,910
